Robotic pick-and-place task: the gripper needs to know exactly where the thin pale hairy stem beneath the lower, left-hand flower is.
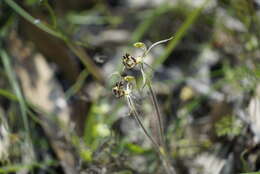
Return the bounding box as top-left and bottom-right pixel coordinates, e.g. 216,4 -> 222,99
126,96 -> 176,174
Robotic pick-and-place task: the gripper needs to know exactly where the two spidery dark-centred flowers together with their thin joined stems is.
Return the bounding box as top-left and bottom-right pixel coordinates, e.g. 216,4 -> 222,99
112,38 -> 176,174
